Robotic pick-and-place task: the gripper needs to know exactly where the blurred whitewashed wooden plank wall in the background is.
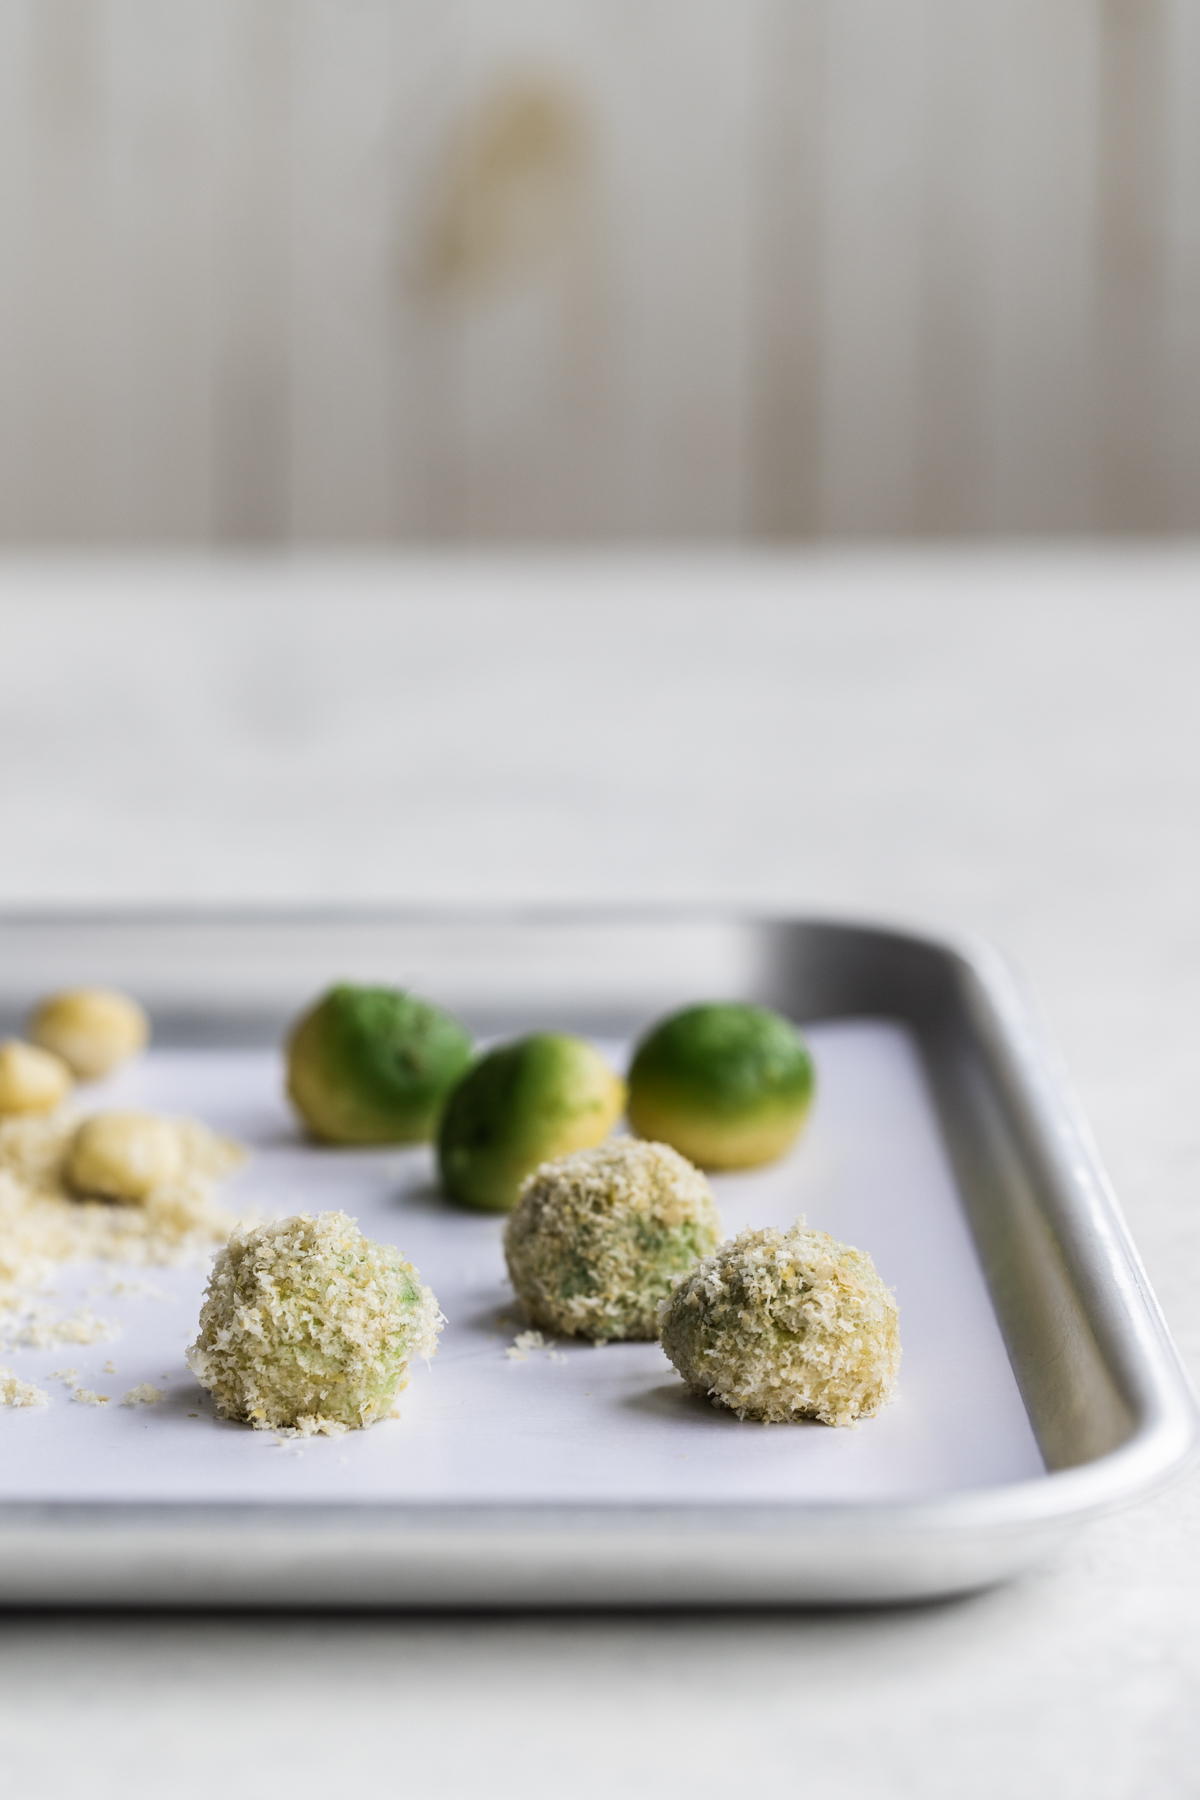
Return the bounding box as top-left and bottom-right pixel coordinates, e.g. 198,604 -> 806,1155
0,0 -> 1200,544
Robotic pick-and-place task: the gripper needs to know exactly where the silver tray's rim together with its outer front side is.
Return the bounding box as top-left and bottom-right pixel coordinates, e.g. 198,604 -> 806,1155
0,907 -> 1200,1606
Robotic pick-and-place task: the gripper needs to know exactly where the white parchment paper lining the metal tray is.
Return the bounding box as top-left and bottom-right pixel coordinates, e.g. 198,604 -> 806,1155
0,1021 -> 1043,1503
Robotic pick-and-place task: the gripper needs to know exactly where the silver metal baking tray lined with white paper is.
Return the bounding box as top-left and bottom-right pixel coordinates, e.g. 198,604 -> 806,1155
0,913 -> 1196,1607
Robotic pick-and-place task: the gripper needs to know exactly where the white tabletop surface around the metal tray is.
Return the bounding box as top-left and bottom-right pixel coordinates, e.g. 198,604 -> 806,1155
0,551 -> 1200,1800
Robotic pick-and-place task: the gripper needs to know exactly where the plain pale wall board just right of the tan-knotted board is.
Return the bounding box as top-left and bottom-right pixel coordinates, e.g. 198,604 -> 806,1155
606,0 -> 759,538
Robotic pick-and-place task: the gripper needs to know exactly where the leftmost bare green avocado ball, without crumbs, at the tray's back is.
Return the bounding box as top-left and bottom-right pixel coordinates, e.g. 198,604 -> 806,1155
288,983 -> 473,1143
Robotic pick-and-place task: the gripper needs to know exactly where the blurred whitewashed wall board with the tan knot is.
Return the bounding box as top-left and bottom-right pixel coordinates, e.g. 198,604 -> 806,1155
447,0 -> 617,540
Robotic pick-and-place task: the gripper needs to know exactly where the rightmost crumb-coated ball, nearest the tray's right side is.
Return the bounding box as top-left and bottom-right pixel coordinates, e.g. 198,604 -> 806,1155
660,1224 -> 900,1426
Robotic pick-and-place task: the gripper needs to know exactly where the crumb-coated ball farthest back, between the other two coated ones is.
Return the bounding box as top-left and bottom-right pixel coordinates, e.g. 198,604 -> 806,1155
504,1138 -> 721,1341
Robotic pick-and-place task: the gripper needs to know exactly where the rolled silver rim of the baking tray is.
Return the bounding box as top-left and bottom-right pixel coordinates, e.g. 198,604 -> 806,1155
0,904 -> 1200,1604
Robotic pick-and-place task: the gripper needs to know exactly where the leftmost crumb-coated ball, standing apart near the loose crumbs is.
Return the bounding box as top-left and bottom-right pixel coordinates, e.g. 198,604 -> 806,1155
187,1213 -> 443,1435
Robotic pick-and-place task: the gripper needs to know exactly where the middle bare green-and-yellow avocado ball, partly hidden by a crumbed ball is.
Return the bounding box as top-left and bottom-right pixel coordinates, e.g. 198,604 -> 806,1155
437,1031 -> 624,1213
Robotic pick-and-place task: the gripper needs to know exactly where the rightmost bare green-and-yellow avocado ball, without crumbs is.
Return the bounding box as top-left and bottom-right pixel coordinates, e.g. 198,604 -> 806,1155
630,1001 -> 815,1168
